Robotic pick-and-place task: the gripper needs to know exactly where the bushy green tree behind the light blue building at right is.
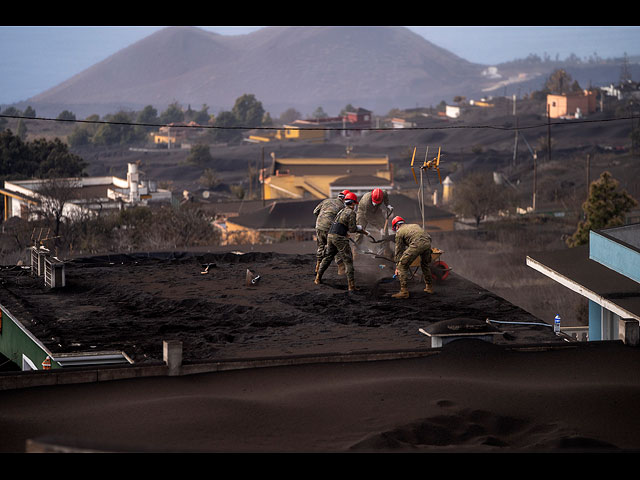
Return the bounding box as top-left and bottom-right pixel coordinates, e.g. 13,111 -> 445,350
567,172 -> 638,247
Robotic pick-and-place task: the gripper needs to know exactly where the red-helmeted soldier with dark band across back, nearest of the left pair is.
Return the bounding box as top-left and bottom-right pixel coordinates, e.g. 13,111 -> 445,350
315,192 -> 368,291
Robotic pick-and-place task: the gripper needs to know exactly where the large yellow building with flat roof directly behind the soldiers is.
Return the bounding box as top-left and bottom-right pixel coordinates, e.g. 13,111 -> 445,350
263,154 -> 393,199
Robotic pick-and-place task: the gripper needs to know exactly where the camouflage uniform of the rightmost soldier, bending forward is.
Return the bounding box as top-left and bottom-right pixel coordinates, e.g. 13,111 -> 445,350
394,223 -> 433,293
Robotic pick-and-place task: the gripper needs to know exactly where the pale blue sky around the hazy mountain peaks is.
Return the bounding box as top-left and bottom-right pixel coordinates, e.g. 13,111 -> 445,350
0,26 -> 640,105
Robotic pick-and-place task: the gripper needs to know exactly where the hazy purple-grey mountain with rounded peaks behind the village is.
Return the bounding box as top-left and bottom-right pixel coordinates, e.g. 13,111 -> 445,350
24,27 -> 636,118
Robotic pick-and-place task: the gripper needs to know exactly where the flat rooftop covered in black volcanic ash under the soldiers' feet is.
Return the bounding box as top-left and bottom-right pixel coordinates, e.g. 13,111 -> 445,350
0,247 -> 564,363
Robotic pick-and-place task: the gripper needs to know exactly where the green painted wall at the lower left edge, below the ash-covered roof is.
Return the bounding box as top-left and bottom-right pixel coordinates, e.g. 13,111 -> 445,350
0,305 -> 61,370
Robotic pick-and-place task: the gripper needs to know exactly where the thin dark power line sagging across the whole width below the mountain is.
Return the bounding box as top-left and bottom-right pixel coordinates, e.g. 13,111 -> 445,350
0,114 -> 640,132
